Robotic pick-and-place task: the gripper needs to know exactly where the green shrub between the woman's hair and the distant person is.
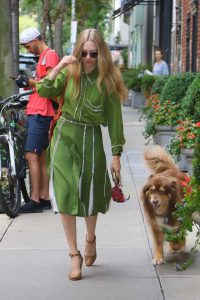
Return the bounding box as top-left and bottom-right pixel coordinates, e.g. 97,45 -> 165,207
122,65 -> 151,92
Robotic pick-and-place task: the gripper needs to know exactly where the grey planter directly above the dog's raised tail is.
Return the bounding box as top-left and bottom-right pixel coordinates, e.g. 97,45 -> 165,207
153,126 -> 176,147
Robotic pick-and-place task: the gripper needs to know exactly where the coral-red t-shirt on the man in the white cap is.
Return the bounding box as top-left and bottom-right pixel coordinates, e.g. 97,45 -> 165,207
26,48 -> 60,117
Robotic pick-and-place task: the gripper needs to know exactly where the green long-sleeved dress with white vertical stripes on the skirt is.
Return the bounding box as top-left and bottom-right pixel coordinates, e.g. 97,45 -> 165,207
36,69 -> 125,217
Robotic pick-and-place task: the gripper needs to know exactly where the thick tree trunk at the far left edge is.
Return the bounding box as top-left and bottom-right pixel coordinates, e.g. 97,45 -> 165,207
0,0 -> 15,97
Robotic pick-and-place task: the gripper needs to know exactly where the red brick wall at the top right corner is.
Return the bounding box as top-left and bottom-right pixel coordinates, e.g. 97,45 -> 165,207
181,0 -> 200,72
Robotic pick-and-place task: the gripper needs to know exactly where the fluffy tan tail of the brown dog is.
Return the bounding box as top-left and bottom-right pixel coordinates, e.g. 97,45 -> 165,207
144,146 -> 178,174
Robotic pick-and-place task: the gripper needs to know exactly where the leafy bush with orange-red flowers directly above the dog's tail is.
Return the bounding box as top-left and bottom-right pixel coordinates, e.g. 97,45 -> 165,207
141,95 -> 180,139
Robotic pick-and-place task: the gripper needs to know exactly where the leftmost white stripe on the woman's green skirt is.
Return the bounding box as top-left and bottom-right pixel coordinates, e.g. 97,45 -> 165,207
49,120 -> 65,213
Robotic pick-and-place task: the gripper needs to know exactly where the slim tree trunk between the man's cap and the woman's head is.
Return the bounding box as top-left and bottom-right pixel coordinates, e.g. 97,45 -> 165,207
54,0 -> 65,57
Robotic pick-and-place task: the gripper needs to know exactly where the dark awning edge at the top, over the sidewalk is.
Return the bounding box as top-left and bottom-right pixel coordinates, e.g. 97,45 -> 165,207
112,0 -> 160,19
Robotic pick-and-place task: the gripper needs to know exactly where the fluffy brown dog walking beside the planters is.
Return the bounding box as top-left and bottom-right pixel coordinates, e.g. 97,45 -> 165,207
141,146 -> 185,265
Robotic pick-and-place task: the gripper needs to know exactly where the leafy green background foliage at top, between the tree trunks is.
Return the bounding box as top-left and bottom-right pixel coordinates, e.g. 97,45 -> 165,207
20,0 -> 112,42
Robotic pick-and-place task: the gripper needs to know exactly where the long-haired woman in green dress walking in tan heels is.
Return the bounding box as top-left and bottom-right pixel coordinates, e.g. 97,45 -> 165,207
37,29 -> 127,280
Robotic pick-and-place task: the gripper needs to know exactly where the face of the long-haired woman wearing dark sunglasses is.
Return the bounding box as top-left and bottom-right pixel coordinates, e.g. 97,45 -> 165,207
81,41 -> 98,72
